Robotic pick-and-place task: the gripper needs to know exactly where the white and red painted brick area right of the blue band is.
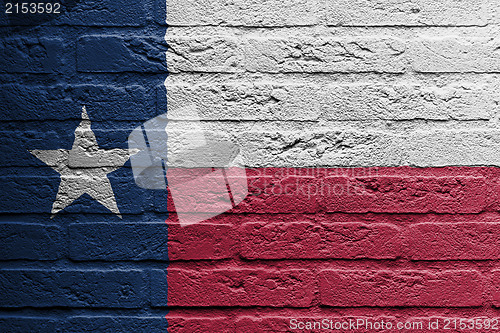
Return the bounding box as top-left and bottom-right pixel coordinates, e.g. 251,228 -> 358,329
163,0 -> 500,332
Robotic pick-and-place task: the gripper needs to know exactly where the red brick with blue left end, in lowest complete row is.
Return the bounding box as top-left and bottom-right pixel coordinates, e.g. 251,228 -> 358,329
156,268 -> 314,307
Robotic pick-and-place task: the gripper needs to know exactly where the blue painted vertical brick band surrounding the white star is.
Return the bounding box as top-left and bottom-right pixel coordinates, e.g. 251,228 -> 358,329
0,0 -> 168,333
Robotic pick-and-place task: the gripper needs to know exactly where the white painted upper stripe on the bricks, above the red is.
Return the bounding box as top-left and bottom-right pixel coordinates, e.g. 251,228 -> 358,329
164,0 -> 500,167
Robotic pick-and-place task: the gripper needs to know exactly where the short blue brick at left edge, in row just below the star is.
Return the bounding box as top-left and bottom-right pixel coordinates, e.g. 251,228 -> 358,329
0,223 -> 66,260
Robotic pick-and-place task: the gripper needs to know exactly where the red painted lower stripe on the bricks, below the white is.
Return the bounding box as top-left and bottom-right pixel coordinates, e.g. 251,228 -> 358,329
167,167 -> 500,326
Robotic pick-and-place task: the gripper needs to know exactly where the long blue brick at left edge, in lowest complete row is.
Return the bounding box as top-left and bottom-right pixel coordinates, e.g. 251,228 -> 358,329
0,269 -> 148,308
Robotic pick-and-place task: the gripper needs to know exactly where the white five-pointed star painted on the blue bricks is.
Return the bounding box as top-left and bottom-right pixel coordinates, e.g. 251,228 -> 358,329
30,106 -> 129,218
